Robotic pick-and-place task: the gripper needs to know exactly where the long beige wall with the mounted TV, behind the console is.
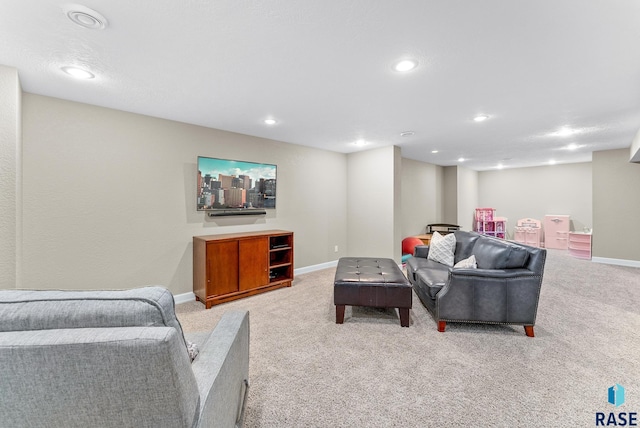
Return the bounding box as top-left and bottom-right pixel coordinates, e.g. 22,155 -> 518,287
21,94 -> 347,293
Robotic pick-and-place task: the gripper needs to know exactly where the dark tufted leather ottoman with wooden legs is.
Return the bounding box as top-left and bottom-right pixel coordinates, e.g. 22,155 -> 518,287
333,257 -> 413,327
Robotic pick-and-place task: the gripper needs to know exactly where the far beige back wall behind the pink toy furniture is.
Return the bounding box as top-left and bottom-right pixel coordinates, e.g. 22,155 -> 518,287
478,162 -> 593,238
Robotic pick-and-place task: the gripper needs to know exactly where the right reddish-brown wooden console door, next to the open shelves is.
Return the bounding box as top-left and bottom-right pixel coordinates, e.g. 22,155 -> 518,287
239,236 -> 269,291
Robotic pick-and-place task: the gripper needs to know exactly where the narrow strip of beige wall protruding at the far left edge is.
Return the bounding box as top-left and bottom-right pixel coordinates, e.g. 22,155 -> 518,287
0,66 -> 22,289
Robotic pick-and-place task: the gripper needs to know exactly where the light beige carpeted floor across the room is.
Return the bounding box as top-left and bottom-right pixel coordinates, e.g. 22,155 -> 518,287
177,250 -> 640,428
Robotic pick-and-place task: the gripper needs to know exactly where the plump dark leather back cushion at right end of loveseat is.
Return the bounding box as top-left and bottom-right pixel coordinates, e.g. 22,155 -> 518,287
473,236 -> 529,269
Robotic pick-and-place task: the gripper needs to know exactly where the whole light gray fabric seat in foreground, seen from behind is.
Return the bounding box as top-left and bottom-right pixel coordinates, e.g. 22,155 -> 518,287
0,287 -> 249,428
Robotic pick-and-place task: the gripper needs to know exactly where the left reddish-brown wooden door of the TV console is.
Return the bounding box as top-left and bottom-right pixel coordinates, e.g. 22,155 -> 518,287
207,240 -> 238,296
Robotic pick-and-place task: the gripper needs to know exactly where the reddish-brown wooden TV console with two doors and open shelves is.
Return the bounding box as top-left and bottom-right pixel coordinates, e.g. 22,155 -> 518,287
193,230 -> 293,309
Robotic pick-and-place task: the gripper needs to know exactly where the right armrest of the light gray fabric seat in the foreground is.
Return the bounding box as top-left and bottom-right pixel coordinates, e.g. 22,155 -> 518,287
192,311 -> 249,427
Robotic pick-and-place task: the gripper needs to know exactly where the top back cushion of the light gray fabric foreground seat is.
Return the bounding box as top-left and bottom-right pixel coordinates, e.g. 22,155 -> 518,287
0,287 -> 184,341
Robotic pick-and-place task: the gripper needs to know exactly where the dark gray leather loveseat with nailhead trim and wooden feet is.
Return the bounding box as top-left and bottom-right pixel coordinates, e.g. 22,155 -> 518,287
407,231 -> 547,337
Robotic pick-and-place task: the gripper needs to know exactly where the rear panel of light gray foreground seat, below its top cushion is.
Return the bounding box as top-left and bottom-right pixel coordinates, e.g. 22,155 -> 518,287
0,326 -> 199,428
